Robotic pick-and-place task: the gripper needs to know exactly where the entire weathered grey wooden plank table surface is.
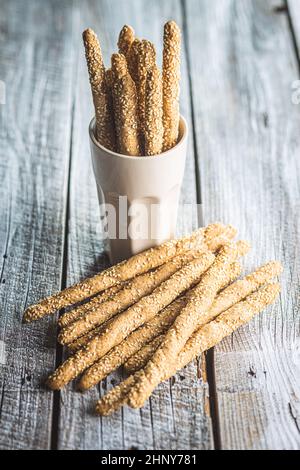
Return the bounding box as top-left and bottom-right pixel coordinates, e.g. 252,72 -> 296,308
0,0 -> 300,449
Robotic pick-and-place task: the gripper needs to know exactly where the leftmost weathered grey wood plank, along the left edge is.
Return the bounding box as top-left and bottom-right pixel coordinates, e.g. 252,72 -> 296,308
0,0 -> 72,449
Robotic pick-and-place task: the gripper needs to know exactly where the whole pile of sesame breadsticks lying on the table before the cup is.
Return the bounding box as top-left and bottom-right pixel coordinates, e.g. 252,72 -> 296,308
24,223 -> 282,415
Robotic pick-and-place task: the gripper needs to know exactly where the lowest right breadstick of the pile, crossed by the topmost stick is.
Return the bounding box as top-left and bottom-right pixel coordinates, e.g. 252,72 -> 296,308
96,284 -> 280,416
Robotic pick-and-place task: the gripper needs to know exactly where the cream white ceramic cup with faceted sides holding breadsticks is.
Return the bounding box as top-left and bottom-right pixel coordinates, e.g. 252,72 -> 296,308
89,117 -> 188,263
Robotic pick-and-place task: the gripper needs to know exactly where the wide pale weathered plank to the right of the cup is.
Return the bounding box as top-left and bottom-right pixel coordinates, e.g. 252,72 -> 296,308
186,0 -> 300,449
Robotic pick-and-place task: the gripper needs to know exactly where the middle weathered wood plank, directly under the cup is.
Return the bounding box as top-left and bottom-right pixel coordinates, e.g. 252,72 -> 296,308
58,0 -> 212,449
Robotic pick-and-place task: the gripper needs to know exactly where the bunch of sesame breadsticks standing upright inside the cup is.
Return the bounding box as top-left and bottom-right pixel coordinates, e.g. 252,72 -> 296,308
83,21 -> 181,156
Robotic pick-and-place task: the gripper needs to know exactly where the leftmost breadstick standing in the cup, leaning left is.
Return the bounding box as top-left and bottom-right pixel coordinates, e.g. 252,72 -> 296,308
82,29 -> 116,150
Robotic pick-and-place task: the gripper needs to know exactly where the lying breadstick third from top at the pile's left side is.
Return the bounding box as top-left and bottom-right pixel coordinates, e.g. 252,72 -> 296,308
58,251 -> 209,345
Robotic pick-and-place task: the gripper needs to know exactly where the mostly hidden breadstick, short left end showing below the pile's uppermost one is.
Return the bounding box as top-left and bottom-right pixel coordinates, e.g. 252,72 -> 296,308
57,281 -> 124,328
